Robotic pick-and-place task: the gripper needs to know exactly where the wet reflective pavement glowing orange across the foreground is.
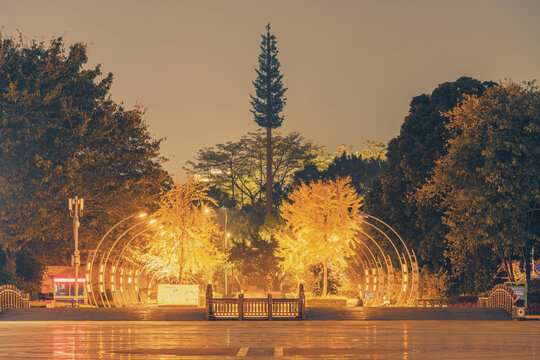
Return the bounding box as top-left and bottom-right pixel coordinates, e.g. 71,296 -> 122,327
0,321 -> 540,359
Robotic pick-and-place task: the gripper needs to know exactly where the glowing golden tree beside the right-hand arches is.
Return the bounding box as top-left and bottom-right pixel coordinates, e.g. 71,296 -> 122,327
278,178 -> 363,296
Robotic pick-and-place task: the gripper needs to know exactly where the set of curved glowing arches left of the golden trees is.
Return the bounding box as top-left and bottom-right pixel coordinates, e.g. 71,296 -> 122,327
85,215 -> 158,307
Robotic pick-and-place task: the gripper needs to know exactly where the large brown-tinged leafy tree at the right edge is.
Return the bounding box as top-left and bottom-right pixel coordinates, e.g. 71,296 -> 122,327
417,82 -> 540,292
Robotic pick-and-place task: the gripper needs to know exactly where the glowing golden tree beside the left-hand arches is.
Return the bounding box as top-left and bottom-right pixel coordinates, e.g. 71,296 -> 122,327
143,179 -> 226,284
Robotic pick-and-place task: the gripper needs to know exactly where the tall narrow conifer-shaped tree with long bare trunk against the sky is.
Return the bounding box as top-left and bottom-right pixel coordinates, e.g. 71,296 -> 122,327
250,23 -> 287,215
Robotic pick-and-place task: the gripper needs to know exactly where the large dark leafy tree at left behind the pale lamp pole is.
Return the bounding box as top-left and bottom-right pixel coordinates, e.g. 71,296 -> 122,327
0,34 -> 168,276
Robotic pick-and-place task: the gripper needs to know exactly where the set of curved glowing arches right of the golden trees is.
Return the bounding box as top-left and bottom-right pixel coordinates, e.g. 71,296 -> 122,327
347,214 -> 419,306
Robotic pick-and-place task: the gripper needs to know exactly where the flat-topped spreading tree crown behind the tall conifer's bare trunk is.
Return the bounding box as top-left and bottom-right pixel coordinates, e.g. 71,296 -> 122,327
185,131 -> 323,208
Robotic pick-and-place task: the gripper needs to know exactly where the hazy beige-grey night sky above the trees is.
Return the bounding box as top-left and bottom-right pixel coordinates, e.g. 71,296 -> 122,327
0,0 -> 540,171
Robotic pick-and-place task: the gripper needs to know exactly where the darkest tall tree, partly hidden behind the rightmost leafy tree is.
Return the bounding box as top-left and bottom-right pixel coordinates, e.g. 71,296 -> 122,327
366,77 -> 493,272
